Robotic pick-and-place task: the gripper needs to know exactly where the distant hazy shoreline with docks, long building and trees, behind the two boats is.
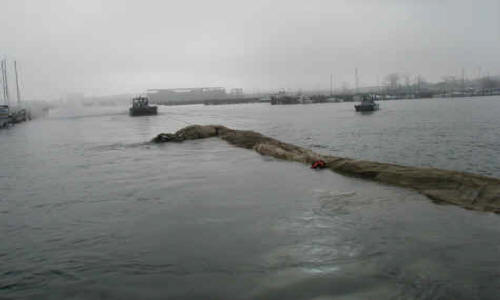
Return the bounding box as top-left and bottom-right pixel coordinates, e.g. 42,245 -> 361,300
135,72 -> 500,111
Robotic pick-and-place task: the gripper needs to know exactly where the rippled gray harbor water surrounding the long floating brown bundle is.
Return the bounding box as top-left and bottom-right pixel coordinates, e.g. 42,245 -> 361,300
0,97 -> 500,300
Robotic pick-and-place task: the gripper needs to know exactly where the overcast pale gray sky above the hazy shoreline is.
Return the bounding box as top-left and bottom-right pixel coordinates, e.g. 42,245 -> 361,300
0,0 -> 500,99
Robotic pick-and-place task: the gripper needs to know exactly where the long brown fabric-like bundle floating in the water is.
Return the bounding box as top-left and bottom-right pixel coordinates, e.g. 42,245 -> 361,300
152,125 -> 500,213
